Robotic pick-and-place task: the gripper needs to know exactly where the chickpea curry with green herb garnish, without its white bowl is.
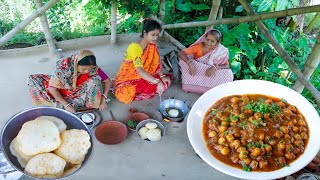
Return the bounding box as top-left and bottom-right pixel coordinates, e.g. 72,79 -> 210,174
203,94 -> 309,172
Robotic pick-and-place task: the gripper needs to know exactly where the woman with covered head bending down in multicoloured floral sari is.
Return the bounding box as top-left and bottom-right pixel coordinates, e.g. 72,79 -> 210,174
28,50 -> 111,112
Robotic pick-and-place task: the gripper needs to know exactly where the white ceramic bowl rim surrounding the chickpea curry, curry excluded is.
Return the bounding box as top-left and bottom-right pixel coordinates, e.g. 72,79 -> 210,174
187,80 -> 320,179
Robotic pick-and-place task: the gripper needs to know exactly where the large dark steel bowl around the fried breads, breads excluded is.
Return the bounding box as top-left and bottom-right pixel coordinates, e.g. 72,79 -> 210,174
1,107 -> 93,179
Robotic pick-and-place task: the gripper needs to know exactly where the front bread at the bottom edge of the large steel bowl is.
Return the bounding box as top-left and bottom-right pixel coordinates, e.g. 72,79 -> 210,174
24,153 -> 66,178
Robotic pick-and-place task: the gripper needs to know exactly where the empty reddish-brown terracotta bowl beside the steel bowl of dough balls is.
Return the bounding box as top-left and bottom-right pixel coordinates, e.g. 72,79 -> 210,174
95,120 -> 128,144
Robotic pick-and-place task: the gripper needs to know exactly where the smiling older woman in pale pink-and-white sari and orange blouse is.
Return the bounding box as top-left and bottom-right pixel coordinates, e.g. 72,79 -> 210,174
178,29 -> 233,93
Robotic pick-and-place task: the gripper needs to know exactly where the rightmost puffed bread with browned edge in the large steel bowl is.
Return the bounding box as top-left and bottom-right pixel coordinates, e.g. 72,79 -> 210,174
54,129 -> 91,164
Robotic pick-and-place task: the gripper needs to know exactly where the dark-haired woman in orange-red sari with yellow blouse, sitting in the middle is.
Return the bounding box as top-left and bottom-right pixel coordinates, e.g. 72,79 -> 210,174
114,20 -> 171,104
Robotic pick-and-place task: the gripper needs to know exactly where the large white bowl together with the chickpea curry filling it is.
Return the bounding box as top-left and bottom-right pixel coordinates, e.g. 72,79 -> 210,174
187,80 -> 320,179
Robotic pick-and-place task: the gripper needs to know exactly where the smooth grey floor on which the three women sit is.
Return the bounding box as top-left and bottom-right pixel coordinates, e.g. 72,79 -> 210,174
0,35 -> 240,180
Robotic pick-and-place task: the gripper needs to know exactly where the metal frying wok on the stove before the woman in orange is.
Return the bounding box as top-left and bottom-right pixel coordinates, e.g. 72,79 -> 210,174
158,99 -> 190,122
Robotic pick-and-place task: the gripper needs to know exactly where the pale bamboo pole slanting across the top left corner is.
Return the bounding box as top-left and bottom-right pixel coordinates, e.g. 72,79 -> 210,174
0,0 -> 59,46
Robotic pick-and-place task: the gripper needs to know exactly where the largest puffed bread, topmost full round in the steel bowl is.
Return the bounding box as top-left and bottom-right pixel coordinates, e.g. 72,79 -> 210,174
17,119 -> 61,156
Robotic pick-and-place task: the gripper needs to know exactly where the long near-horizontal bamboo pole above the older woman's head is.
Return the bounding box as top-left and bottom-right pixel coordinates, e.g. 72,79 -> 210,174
162,5 -> 320,29
